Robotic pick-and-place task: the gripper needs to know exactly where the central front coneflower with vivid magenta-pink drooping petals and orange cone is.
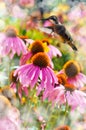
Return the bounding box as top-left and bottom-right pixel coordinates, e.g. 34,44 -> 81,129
14,52 -> 57,93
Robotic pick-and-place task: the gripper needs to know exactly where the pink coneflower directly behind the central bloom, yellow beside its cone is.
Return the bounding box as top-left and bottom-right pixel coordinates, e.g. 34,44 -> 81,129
20,39 -> 62,65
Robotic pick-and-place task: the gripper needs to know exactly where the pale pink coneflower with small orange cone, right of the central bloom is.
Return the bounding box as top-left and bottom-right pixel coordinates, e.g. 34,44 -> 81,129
43,74 -> 67,106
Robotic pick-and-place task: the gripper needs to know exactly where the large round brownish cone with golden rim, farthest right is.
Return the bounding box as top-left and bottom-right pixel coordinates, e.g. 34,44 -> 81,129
63,60 -> 80,78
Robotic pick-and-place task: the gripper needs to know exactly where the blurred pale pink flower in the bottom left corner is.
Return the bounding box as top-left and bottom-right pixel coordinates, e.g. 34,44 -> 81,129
0,95 -> 21,130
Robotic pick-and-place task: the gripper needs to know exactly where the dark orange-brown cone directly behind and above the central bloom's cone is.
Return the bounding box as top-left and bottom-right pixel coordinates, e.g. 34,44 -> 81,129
30,40 -> 44,55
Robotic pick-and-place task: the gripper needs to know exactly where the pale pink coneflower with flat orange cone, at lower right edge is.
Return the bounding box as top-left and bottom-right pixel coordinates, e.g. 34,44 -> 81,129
64,83 -> 86,110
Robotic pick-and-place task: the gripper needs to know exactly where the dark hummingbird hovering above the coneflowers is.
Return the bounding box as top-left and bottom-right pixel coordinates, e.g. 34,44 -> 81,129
41,15 -> 77,51
